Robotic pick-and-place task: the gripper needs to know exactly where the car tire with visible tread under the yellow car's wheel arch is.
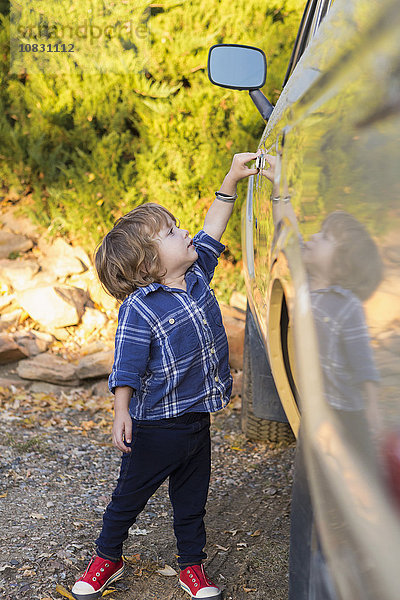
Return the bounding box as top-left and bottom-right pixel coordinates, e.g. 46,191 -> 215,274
241,328 -> 295,445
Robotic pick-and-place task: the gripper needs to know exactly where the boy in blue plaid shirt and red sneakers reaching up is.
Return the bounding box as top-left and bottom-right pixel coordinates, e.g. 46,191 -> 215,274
72,152 -> 259,600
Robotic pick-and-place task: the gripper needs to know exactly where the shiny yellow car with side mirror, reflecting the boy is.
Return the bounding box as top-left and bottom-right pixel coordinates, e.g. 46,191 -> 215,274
208,0 -> 400,600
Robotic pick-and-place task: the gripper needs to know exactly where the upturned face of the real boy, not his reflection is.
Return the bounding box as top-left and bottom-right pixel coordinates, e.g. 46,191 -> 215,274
156,221 -> 198,281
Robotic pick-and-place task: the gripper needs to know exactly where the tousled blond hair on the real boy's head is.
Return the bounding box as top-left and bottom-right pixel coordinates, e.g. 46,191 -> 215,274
94,202 -> 177,301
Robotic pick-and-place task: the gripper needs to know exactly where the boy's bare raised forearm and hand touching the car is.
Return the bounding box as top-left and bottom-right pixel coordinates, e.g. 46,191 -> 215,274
203,151 -> 260,242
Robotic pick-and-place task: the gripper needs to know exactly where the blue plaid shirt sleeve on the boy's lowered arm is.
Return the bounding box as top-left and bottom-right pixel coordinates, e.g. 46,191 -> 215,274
108,300 -> 151,394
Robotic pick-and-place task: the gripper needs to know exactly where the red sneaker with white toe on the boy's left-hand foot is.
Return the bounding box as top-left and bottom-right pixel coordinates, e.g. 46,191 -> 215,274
72,556 -> 124,600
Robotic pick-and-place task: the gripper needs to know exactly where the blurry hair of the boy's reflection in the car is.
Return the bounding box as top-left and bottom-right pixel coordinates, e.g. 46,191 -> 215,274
322,210 -> 383,301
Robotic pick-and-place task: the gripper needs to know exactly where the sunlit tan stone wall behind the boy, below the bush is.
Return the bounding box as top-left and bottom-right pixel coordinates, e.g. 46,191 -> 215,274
0,207 -> 246,395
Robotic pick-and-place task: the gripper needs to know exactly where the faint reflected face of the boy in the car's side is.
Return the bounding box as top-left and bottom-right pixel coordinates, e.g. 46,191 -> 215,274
303,227 -> 336,283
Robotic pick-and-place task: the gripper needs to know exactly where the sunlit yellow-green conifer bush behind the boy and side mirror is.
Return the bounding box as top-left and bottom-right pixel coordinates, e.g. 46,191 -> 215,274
0,0 -> 304,299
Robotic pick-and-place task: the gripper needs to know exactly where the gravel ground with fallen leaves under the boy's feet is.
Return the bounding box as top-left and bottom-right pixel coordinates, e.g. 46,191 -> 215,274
0,388 -> 294,600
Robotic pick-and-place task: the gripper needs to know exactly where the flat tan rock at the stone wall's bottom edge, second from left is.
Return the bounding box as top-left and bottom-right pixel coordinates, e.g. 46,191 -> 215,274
17,352 -> 79,385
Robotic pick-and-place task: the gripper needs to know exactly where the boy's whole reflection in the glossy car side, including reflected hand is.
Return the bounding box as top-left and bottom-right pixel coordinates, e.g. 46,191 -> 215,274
263,155 -> 382,450
